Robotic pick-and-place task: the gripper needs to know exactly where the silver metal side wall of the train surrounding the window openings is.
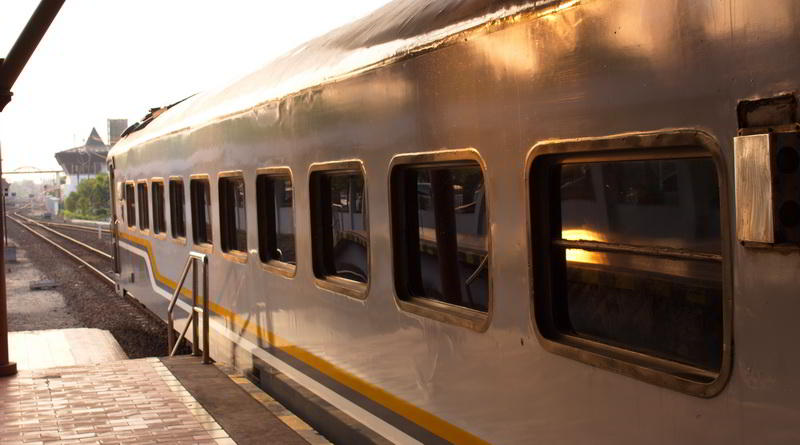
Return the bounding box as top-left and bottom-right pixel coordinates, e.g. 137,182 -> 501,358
112,0 -> 800,445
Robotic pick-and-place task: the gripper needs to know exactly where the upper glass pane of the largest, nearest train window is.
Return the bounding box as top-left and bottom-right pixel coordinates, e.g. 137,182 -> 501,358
560,159 -> 721,253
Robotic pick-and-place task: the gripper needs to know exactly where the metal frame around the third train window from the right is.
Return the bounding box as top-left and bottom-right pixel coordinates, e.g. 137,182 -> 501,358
308,159 -> 372,300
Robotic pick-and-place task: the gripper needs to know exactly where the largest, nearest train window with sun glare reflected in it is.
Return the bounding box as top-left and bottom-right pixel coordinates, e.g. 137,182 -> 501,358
529,131 -> 726,389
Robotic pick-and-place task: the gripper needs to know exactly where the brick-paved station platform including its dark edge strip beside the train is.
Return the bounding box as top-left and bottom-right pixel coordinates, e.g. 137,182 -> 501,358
0,330 -> 328,445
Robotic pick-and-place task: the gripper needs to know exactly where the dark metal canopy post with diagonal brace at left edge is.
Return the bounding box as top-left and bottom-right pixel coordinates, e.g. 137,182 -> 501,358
0,0 -> 64,377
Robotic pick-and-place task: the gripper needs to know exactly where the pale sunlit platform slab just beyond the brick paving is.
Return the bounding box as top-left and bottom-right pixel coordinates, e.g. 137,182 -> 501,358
8,328 -> 128,370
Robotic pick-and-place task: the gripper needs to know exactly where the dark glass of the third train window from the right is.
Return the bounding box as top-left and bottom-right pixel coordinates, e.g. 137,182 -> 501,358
311,171 -> 369,283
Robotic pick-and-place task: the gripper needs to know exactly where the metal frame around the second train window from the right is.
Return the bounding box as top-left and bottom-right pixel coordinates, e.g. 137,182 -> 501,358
387,148 -> 494,332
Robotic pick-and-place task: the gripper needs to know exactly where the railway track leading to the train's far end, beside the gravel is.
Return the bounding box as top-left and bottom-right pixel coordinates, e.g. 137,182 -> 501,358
8,213 -> 115,287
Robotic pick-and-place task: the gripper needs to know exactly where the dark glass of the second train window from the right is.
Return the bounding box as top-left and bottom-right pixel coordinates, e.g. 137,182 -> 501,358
392,162 -> 489,311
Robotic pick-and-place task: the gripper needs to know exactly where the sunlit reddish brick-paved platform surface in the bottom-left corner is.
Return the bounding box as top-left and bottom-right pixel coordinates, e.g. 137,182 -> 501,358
0,358 -> 236,445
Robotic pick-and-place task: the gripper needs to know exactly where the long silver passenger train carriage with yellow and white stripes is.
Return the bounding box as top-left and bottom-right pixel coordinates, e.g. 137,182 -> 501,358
108,0 -> 800,444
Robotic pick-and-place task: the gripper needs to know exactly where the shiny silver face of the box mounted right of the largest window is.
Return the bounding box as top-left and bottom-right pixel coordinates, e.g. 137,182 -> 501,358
733,134 -> 775,243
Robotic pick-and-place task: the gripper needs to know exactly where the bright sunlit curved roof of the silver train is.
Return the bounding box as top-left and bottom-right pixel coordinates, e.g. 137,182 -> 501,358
109,0 -> 564,156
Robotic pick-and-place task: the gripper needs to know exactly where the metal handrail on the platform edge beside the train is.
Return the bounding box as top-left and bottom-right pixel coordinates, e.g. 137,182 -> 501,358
167,252 -> 211,364
